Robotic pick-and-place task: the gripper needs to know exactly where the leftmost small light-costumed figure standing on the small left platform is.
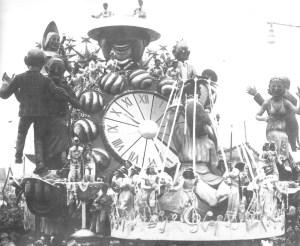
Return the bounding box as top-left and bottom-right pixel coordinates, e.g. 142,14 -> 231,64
68,137 -> 83,182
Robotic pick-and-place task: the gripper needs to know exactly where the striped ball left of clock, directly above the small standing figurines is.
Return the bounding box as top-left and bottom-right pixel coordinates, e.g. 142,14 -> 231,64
73,118 -> 98,143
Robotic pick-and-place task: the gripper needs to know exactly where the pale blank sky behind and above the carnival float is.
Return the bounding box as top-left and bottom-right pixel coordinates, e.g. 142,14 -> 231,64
0,0 -> 300,176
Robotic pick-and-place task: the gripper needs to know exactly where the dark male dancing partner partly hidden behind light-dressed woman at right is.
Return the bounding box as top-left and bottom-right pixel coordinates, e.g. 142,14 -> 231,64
247,77 -> 300,151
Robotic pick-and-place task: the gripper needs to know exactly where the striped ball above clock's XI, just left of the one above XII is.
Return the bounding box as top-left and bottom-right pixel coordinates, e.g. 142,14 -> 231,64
99,72 -> 126,95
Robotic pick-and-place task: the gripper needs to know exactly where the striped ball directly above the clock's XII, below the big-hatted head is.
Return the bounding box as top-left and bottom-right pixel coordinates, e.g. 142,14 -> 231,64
129,69 -> 153,89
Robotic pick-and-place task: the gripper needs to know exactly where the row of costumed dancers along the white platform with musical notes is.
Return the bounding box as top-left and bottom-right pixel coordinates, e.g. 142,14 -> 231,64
85,143 -> 285,229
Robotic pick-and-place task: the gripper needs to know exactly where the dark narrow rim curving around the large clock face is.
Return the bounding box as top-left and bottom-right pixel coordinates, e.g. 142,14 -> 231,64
100,90 -> 177,167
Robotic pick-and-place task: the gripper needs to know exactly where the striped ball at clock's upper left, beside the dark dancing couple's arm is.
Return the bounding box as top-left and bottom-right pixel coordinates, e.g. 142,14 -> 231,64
79,91 -> 103,114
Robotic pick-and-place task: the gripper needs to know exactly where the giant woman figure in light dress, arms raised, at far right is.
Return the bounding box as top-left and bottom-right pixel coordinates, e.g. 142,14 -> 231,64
256,77 -> 300,174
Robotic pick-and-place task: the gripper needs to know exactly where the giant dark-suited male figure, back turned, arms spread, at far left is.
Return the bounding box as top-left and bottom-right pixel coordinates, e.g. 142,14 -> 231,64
0,49 -> 68,174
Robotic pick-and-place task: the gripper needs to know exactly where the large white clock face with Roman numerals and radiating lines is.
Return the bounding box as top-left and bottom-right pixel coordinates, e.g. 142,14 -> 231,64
102,91 -> 179,168
